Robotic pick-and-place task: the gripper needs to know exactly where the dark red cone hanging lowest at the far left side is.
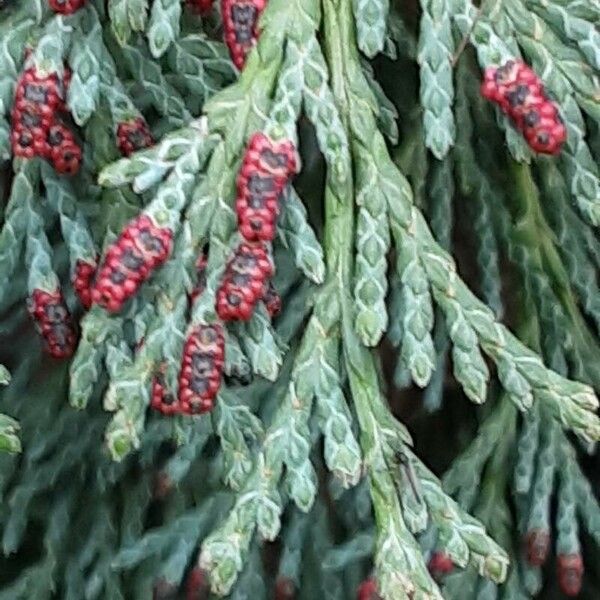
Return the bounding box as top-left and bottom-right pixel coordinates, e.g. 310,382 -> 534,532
27,289 -> 77,358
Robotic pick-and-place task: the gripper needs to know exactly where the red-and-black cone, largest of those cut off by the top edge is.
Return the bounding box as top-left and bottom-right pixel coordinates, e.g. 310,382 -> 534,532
221,0 -> 267,69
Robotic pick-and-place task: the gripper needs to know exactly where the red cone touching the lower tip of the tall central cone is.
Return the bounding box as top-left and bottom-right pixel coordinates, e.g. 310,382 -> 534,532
217,242 -> 273,321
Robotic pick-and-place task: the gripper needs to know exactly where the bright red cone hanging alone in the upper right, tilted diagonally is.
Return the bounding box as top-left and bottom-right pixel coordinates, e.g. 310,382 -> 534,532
481,60 -> 567,154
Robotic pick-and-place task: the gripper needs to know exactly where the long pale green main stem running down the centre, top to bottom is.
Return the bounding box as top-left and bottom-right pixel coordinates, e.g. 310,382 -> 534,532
324,15 -> 422,598
